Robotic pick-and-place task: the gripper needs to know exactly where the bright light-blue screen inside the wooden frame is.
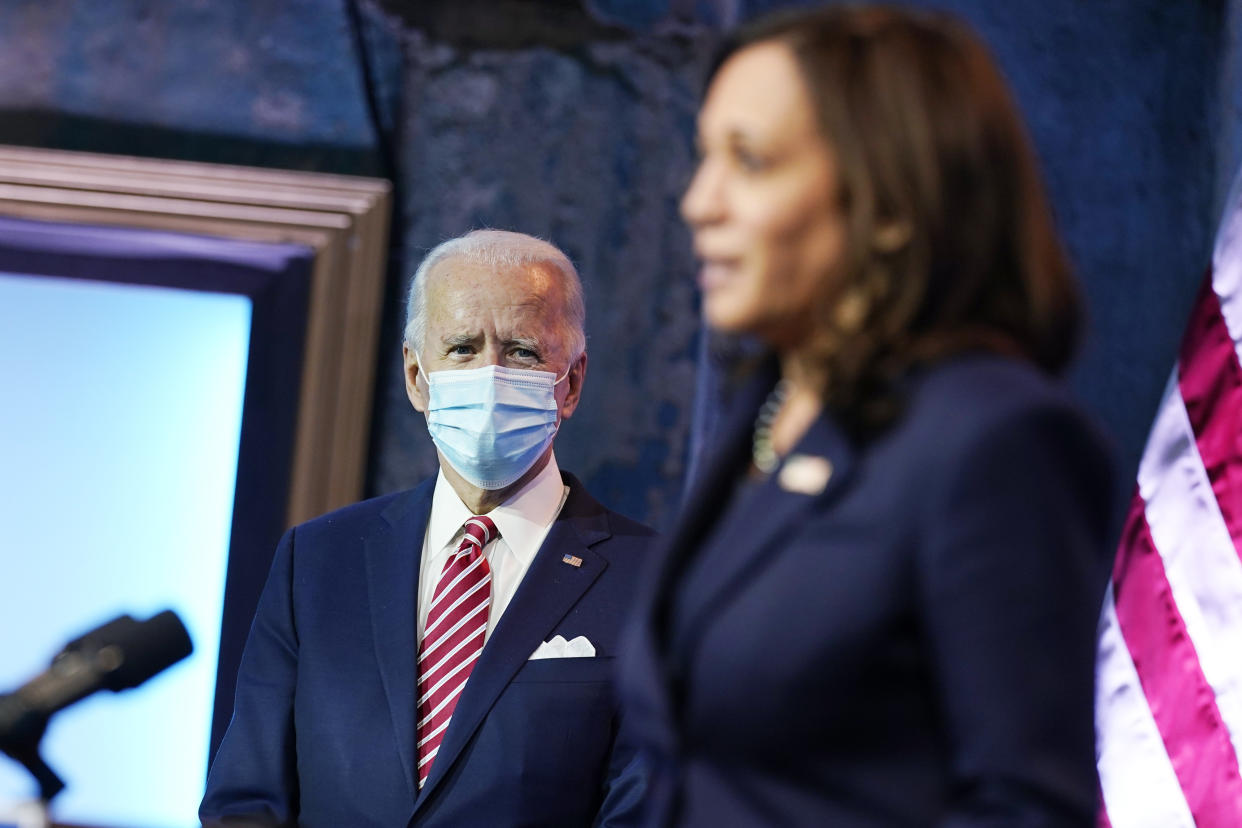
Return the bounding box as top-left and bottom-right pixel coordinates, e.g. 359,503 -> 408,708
0,273 -> 251,828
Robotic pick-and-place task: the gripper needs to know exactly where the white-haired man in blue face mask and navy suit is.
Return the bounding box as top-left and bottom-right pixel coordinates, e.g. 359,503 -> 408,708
200,231 -> 651,828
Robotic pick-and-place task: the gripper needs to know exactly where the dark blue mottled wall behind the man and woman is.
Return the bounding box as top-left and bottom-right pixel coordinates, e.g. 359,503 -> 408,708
0,0 -> 1227,525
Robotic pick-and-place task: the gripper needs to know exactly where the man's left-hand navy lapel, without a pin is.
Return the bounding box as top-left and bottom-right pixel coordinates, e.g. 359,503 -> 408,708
365,478 -> 436,802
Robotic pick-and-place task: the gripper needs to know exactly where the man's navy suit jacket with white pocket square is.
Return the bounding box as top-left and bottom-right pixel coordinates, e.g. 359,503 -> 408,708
200,474 -> 652,828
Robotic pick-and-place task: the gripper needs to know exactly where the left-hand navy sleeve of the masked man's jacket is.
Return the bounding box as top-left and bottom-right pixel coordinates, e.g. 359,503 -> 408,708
199,529 -> 298,826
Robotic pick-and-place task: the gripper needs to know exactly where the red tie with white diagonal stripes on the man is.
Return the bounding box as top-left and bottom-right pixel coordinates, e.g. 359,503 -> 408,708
419,516 -> 501,788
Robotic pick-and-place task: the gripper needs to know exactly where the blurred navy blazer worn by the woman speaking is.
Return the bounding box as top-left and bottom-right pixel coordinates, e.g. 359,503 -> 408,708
622,355 -> 1114,828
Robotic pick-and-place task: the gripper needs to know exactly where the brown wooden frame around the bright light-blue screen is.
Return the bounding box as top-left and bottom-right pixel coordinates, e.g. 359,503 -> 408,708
0,146 -> 391,525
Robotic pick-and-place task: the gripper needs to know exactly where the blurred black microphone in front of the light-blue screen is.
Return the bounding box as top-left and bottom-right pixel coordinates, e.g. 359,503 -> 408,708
0,610 -> 194,757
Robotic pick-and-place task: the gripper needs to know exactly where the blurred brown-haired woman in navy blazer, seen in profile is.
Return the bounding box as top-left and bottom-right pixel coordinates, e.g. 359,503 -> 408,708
623,6 -> 1113,827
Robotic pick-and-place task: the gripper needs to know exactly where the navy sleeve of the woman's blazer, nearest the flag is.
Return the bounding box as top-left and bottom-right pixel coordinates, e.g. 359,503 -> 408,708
918,406 -> 1113,828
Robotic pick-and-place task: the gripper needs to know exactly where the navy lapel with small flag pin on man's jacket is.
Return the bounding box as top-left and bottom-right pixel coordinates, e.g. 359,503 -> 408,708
415,474 -> 611,811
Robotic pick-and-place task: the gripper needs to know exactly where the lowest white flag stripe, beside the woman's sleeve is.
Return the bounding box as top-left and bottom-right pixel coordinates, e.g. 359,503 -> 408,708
1095,585 -> 1195,828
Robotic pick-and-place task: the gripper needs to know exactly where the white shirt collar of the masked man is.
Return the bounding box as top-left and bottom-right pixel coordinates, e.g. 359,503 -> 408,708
427,454 -> 568,562
